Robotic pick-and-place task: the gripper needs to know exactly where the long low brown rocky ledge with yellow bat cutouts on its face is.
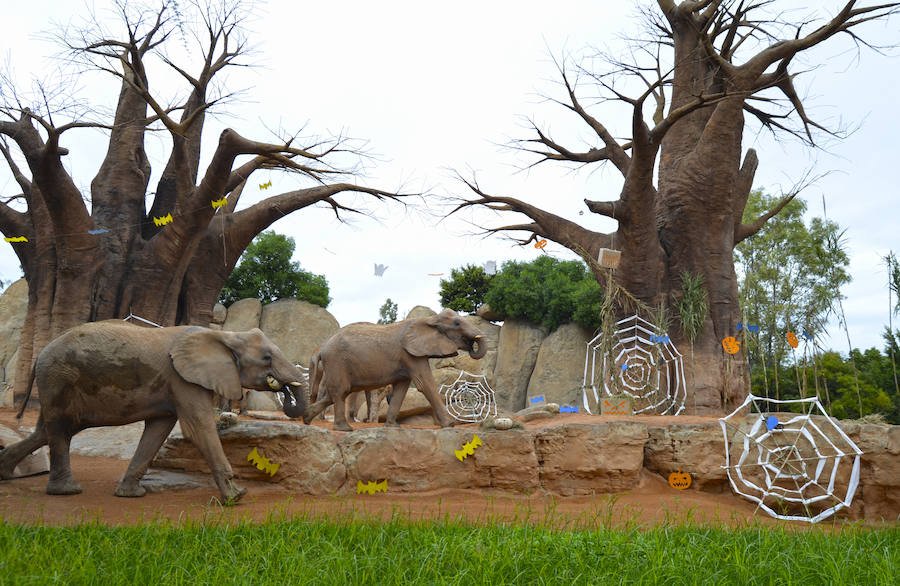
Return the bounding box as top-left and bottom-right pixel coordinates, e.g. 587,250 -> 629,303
153,418 -> 900,521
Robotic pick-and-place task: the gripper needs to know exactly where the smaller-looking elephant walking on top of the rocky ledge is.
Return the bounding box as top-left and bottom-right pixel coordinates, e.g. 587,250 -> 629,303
304,309 -> 487,431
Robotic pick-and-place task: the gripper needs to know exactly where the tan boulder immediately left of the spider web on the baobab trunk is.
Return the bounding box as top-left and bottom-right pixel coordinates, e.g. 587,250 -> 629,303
526,324 -> 592,405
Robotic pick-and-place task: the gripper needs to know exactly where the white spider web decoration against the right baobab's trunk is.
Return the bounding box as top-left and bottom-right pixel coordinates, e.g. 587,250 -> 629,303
582,315 -> 687,415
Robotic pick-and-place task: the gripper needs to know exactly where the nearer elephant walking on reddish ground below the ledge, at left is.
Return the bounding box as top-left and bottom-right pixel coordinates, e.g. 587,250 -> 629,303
0,320 -> 306,502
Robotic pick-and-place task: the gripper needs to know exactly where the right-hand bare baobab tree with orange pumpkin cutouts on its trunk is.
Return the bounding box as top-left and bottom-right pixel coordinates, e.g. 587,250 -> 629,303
454,0 -> 897,413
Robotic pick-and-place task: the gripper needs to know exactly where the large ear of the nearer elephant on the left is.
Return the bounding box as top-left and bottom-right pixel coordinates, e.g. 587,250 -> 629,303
169,327 -> 244,400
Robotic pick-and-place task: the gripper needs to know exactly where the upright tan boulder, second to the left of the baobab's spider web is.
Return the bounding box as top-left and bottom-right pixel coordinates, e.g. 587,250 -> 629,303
494,319 -> 547,411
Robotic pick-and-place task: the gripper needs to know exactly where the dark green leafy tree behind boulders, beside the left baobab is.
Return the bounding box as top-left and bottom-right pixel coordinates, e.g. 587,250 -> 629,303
219,230 -> 331,307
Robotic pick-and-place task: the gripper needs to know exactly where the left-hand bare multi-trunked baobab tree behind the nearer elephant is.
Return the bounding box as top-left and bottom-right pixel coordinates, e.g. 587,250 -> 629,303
0,0 -> 400,395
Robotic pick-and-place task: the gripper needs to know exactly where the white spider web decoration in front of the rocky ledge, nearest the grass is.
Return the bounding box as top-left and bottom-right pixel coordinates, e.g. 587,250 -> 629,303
719,395 -> 862,523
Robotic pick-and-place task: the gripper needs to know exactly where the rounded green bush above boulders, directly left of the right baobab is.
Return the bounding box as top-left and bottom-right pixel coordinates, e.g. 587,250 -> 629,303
484,255 -> 603,331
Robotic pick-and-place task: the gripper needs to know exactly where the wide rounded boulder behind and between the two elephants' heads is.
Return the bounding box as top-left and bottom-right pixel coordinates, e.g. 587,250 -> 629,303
259,299 -> 341,366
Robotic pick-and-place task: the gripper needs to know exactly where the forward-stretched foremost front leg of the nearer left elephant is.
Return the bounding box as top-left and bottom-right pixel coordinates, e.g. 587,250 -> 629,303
175,388 -> 247,504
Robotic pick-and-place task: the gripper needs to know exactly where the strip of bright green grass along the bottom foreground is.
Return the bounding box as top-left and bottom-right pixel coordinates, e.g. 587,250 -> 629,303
0,508 -> 900,586
